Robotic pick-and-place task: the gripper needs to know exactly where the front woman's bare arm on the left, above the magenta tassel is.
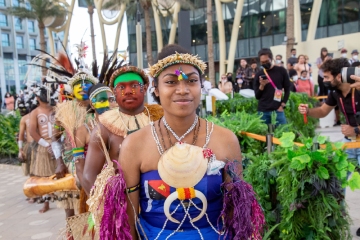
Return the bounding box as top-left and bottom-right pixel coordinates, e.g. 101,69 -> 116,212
119,135 -> 141,240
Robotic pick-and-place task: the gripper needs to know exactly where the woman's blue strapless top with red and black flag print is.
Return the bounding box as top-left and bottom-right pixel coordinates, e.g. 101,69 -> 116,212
140,170 -> 223,231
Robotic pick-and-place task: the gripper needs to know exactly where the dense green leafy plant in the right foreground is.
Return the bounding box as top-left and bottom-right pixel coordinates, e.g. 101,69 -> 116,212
244,132 -> 360,239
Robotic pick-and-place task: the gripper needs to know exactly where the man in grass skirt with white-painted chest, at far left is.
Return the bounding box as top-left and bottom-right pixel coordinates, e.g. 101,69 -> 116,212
30,86 -> 56,213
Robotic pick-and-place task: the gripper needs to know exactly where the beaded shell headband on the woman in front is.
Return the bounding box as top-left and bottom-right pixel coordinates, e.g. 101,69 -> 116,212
149,52 -> 206,78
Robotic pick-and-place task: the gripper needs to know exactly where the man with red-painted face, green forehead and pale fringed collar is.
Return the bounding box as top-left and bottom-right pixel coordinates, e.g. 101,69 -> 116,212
78,66 -> 163,194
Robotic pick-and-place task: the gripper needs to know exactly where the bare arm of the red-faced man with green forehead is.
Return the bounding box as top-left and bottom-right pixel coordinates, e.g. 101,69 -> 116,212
79,123 -> 109,195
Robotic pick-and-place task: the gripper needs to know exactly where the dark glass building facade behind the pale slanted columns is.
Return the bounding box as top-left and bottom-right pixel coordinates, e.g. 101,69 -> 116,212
128,0 -> 360,70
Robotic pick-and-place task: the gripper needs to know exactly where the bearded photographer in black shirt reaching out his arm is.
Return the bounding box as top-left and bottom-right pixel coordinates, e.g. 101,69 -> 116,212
299,58 -> 360,159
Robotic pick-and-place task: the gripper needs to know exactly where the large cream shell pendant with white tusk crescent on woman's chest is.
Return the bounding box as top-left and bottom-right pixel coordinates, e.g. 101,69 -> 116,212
158,143 -> 208,224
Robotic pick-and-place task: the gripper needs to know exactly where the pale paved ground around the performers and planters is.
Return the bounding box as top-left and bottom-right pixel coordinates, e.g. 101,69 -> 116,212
0,124 -> 360,240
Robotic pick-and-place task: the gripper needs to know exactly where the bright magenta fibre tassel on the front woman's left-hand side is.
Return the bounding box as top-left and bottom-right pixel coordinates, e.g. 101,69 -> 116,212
100,161 -> 131,240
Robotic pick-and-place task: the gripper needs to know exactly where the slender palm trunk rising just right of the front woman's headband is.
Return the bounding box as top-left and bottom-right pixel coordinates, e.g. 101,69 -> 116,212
206,0 -> 215,86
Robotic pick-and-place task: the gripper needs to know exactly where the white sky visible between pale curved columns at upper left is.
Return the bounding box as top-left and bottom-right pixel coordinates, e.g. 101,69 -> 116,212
67,0 -> 128,64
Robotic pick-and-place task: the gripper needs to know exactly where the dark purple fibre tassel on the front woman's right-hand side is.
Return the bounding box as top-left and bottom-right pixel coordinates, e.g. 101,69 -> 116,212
218,161 -> 265,239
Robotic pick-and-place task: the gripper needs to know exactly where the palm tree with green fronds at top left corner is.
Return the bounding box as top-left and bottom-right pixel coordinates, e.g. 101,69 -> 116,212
7,0 -> 66,76
